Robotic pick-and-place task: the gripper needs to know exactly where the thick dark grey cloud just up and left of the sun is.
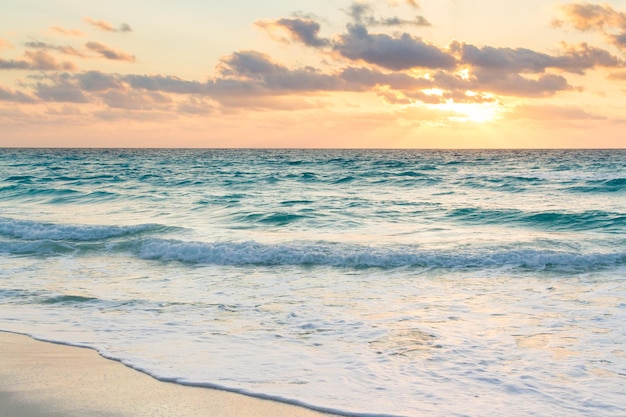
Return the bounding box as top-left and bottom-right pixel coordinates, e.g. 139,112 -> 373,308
334,24 -> 456,71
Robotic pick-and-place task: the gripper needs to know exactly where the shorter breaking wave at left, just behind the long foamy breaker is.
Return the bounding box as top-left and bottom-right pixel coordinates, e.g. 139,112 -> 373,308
0,218 -> 170,240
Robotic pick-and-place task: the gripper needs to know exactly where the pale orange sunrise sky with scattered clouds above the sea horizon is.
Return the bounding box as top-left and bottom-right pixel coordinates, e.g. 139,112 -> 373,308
0,0 -> 626,148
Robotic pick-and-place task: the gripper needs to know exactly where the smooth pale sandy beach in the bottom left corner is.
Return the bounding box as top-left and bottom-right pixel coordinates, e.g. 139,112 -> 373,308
0,332 -> 338,417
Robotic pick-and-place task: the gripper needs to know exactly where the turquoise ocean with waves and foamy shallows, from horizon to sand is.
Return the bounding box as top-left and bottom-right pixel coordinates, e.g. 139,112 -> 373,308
0,149 -> 626,417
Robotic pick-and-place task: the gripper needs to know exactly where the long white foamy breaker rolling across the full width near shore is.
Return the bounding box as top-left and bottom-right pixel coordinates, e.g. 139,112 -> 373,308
0,238 -> 626,272
